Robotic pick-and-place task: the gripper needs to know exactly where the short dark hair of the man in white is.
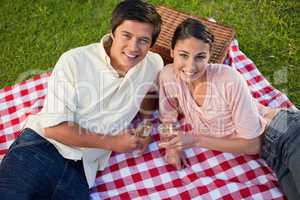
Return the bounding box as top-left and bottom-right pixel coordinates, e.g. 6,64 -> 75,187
111,0 -> 161,47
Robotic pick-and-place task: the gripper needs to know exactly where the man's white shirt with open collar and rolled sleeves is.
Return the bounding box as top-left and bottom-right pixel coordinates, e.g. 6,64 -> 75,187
25,35 -> 163,187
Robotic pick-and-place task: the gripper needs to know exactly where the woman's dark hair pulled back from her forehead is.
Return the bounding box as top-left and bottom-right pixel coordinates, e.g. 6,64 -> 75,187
171,18 -> 214,49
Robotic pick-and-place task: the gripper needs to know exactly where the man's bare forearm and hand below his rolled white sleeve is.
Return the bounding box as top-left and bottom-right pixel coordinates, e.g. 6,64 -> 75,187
44,122 -> 139,152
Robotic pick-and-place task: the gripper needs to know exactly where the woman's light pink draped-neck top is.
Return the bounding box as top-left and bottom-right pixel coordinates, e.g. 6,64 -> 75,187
159,64 -> 276,139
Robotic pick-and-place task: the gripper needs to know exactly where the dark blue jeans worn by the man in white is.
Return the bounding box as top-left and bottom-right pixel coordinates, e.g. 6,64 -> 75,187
0,129 -> 89,200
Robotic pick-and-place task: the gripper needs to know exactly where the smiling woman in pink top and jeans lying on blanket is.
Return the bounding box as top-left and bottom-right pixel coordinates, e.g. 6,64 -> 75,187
159,19 -> 300,199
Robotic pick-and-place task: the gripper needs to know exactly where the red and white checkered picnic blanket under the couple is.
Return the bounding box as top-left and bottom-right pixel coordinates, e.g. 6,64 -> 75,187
0,40 -> 296,200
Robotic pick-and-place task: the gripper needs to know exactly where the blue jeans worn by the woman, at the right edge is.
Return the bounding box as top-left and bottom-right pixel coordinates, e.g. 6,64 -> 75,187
261,110 -> 300,200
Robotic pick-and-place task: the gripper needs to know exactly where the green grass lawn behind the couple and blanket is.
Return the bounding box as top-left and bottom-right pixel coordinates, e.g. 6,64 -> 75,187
0,0 -> 300,108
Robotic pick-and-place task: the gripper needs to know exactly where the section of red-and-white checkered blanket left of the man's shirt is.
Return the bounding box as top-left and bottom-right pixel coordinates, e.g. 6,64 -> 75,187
0,73 -> 50,157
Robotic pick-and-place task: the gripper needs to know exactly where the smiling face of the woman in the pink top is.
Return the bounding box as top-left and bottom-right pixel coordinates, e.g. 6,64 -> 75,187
171,37 -> 210,82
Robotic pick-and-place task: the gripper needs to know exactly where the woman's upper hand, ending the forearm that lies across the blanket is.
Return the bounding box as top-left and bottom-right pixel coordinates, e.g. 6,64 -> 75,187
159,131 -> 199,151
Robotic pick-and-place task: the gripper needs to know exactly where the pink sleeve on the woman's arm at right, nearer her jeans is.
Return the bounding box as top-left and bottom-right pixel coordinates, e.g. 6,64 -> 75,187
226,71 -> 264,139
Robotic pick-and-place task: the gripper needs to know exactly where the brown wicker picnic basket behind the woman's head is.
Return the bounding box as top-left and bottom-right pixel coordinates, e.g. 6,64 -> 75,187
152,6 -> 235,64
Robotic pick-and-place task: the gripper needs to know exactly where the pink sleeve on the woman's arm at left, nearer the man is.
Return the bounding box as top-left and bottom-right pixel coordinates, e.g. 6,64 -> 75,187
159,71 -> 178,123
